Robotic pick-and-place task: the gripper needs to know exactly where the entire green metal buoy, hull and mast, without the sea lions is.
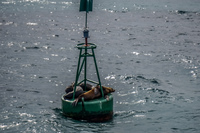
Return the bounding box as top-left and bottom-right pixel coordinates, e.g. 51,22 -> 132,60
61,0 -> 113,122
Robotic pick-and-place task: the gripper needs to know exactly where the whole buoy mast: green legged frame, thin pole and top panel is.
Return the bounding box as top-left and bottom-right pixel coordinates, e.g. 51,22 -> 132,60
73,0 -> 104,99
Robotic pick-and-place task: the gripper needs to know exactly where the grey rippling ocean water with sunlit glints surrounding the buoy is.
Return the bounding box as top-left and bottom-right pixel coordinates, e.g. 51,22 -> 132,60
0,0 -> 200,133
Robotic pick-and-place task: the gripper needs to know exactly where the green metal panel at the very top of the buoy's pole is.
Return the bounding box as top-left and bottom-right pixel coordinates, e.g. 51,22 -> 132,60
79,0 -> 93,12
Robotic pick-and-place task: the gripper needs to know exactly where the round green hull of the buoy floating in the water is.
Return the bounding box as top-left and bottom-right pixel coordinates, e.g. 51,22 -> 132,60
61,94 -> 113,122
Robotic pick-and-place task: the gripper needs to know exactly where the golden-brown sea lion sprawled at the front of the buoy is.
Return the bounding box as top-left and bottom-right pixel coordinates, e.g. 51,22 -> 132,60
72,85 -> 115,106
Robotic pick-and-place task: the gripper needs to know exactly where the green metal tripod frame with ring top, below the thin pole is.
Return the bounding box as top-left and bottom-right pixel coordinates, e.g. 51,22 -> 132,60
73,43 -> 104,100
